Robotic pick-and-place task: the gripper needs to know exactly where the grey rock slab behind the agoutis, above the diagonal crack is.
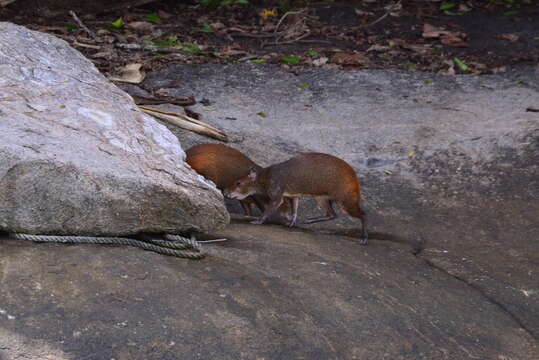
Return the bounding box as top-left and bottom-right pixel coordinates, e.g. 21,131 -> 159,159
141,65 -> 539,344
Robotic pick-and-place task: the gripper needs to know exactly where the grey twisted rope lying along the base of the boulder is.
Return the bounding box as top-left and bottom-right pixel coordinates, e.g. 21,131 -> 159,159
10,233 -> 210,260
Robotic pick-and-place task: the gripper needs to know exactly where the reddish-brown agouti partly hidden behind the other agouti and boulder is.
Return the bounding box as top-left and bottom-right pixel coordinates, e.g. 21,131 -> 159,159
185,144 -> 291,218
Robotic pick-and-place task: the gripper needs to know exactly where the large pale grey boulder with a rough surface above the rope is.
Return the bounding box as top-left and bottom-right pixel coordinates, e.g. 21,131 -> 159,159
0,23 -> 228,235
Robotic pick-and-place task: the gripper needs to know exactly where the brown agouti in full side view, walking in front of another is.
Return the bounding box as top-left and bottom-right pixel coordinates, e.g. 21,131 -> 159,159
224,153 -> 368,245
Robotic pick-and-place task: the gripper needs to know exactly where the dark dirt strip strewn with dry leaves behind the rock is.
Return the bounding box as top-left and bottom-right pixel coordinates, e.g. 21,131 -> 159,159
0,0 -> 539,74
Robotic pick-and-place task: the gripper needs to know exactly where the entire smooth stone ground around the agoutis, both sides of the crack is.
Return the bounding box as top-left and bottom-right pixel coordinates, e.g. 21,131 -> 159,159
0,65 -> 539,360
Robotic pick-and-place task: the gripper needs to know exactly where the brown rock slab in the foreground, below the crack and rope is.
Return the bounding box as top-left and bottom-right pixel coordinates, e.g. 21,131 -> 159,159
0,224 -> 539,360
